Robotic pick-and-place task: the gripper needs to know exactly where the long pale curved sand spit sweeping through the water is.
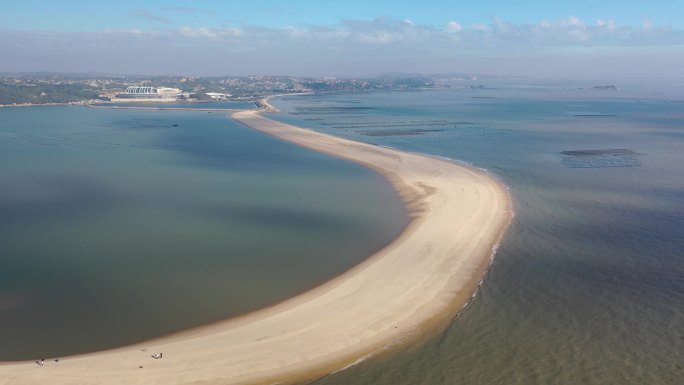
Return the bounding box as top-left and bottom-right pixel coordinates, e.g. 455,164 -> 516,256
0,103 -> 511,385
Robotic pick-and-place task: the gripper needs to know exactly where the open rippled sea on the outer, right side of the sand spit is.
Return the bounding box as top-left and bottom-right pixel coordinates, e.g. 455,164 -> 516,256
271,84 -> 684,385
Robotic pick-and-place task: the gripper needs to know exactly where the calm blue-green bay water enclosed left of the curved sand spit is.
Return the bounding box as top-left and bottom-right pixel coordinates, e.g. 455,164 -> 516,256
0,107 -> 407,360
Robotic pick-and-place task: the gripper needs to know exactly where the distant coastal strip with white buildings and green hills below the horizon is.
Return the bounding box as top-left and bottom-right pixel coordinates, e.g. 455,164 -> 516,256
0,73 -> 520,106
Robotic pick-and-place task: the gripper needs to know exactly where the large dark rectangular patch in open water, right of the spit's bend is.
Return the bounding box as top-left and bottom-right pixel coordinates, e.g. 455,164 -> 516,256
561,148 -> 643,168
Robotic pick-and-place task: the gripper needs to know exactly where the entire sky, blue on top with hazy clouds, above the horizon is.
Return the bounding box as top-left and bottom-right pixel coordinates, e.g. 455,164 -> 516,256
0,0 -> 684,78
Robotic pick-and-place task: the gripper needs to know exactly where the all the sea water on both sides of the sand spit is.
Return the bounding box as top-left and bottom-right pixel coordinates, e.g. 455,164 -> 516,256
0,80 -> 684,385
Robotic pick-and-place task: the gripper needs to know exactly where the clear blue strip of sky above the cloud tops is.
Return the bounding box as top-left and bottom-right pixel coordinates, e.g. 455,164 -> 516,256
0,0 -> 684,31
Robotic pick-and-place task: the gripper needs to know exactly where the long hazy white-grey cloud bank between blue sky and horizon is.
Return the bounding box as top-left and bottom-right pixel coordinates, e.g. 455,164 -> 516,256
0,16 -> 684,77
